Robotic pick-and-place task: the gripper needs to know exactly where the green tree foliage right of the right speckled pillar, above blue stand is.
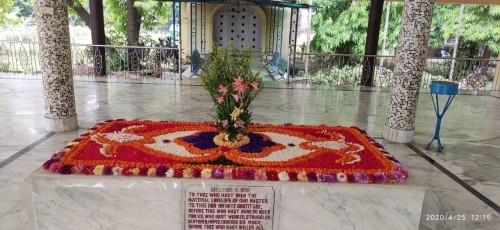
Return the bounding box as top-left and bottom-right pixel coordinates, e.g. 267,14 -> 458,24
429,5 -> 500,82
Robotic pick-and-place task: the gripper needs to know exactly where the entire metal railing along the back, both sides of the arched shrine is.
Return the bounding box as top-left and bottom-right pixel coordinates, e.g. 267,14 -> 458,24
0,41 -> 500,90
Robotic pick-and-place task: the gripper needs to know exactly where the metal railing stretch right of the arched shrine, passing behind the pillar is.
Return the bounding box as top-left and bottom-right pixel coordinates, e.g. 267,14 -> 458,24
290,53 -> 500,90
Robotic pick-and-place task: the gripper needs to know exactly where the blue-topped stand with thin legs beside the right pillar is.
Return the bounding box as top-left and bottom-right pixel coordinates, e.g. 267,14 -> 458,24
426,81 -> 458,152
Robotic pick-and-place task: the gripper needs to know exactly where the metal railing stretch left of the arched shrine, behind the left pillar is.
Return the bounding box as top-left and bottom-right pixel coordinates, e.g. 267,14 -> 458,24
0,41 -> 181,79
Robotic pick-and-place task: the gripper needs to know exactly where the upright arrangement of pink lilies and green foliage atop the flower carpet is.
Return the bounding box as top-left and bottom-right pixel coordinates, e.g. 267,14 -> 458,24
200,44 -> 262,141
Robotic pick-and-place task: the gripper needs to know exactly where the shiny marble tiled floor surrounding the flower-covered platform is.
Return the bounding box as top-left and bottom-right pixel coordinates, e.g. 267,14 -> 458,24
0,75 -> 500,230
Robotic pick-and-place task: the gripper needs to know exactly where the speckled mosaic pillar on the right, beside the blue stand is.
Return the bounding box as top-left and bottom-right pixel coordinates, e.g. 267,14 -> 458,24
383,0 -> 434,143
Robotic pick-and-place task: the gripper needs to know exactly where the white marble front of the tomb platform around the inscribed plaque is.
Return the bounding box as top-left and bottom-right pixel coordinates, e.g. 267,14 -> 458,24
28,169 -> 426,230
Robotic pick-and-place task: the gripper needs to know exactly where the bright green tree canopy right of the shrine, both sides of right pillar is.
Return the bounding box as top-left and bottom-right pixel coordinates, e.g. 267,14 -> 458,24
311,0 -> 500,58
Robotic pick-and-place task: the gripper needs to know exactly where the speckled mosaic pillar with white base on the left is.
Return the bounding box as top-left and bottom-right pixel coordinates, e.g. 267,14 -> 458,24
35,0 -> 78,132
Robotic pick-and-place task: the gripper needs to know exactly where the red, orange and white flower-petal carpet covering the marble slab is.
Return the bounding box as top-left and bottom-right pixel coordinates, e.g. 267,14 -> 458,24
43,119 -> 408,183
